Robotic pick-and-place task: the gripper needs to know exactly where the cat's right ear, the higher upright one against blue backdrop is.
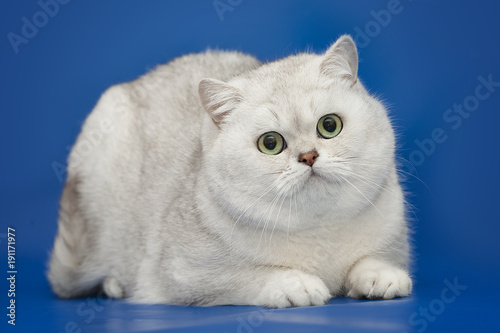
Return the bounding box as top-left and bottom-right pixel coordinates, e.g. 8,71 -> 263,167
320,35 -> 358,84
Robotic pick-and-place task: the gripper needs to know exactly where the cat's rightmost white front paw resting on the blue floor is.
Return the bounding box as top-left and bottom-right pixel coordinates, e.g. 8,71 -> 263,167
347,266 -> 412,299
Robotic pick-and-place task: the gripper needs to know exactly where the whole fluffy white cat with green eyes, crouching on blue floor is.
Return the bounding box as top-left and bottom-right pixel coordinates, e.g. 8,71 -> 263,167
48,36 -> 412,308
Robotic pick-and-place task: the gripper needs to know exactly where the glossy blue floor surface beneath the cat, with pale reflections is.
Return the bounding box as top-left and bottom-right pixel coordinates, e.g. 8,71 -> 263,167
3,264 -> 500,333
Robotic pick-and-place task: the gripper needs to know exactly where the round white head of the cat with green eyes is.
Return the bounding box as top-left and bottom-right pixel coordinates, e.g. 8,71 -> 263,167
199,36 -> 395,230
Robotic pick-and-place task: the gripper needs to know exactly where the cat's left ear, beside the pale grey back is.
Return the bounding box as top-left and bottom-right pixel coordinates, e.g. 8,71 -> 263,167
198,79 -> 242,125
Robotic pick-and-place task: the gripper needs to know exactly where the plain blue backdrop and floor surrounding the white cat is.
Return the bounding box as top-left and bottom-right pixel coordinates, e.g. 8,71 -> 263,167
0,0 -> 500,332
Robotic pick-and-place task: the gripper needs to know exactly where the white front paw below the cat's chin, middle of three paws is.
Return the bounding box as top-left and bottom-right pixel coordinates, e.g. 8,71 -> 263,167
255,269 -> 331,308
